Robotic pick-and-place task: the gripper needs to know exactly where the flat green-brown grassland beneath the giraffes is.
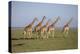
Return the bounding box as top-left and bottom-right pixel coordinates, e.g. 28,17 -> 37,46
11,28 -> 78,52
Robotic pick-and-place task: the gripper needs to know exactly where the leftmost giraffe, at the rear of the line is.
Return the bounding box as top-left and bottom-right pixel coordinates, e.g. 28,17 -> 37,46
23,17 -> 38,39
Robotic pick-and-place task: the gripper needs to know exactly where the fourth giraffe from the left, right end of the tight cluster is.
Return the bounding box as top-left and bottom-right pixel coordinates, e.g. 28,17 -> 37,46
47,16 -> 60,38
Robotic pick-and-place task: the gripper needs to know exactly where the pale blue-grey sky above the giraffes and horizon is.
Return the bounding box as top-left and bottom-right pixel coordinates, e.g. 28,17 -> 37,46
11,1 -> 78,28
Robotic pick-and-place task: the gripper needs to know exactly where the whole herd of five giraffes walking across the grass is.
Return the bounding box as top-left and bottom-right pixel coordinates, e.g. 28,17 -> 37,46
23,16 -> 72,39
